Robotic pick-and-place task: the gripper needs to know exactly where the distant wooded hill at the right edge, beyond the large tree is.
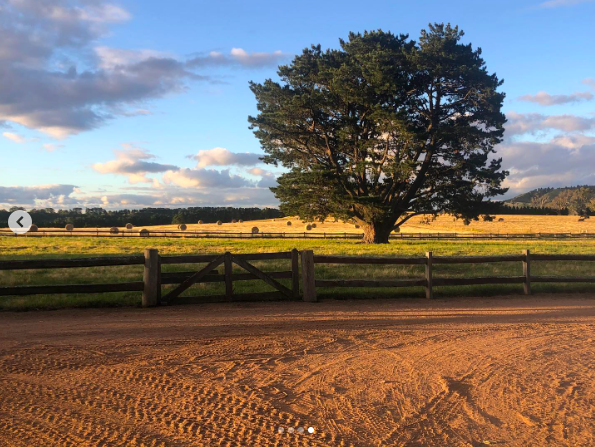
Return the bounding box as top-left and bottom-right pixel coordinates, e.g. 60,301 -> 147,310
504,186 -> 595,215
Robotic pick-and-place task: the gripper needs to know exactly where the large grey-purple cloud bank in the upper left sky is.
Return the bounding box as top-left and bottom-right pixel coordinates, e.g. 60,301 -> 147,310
0,0 -> 284,138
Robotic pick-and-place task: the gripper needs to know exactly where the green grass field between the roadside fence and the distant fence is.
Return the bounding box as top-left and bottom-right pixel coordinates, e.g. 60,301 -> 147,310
0,237 -> 595,310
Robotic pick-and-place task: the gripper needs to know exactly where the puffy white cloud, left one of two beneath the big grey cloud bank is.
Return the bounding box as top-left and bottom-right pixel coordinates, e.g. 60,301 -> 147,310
93,144 -> 178,184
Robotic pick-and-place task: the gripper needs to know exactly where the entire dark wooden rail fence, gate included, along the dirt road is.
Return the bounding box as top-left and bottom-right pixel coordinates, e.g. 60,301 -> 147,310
0,249 -> 595,307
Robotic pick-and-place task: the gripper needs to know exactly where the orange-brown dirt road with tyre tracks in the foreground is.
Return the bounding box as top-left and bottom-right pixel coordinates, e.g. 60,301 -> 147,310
0,295 -> 595,447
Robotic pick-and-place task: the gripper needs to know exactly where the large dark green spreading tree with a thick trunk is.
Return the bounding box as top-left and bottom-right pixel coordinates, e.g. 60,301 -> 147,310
249,24 -> 507,243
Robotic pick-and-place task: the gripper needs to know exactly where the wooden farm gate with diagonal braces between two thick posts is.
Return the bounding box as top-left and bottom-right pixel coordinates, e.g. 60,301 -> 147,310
161,249 -> 300,303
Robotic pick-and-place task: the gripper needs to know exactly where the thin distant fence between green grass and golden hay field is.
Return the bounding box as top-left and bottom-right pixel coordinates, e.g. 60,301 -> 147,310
0,228 -> 595,240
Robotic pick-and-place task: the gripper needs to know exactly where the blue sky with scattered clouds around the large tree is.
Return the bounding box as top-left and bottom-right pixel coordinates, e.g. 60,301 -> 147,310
0,0 -> 595,208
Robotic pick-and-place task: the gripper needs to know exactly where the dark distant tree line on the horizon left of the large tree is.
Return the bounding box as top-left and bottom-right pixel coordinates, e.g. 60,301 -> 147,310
0,207 -> 283,228
